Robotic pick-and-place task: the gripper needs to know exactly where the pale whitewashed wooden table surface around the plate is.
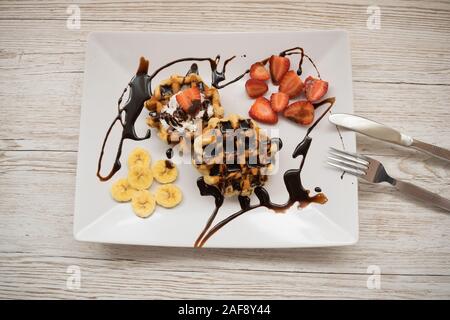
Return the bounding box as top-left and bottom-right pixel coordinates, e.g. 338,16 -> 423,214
0,0 -> 450,299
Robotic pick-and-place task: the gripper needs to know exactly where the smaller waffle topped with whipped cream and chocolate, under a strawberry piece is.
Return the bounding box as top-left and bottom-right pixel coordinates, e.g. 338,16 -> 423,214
145,72 -> 223,148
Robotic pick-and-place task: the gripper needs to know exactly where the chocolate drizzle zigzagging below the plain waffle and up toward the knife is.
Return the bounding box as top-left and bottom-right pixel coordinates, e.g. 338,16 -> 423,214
194,97 -> 335,247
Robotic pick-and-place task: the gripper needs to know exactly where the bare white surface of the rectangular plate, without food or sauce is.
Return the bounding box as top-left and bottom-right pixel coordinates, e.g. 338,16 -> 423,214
74,31 -> 358,248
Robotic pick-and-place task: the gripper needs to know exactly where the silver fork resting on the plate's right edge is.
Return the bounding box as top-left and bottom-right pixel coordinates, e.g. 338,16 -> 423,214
327,148 -> 450,211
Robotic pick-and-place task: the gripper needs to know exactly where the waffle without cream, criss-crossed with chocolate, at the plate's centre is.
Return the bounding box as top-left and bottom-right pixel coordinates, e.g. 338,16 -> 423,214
192,115 -> 281,197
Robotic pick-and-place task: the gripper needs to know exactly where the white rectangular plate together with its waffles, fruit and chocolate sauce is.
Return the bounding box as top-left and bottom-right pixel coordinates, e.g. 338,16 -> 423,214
74,31 -> 358,248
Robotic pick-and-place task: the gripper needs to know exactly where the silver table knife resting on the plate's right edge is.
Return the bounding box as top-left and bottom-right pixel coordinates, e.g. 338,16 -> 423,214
328,113 -> 450,161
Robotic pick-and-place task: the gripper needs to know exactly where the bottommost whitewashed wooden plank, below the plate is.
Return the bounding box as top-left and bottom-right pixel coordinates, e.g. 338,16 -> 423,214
0,255 -> 450,299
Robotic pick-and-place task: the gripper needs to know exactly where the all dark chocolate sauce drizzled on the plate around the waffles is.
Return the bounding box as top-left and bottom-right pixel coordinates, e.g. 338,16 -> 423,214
97,47 -> 335,247
